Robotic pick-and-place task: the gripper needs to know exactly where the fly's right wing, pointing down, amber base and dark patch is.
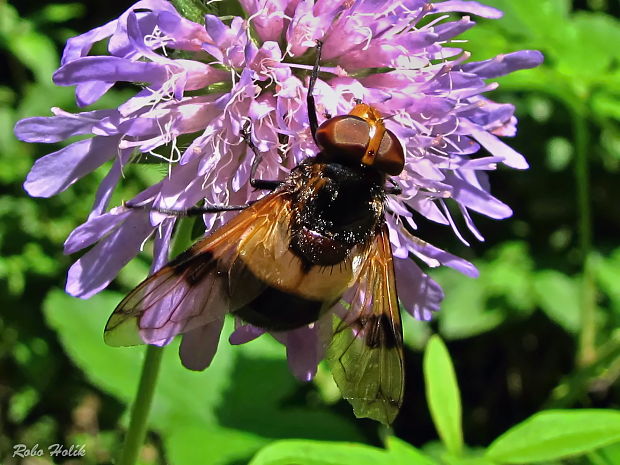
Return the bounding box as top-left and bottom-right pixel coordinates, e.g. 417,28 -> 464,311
327,224 -> 404,425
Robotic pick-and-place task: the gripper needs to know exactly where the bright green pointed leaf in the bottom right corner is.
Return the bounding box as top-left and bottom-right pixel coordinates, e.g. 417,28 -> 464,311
487,409 -> 620,464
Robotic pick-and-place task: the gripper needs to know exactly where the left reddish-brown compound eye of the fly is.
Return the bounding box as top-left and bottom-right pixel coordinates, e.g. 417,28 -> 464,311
316,115 -> 370,163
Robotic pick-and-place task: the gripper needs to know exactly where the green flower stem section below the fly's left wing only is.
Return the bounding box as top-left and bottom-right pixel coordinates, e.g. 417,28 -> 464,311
118,346 -> 164,465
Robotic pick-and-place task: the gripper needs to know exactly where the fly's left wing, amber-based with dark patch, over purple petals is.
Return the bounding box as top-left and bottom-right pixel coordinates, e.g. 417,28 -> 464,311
104,192 -> 290,346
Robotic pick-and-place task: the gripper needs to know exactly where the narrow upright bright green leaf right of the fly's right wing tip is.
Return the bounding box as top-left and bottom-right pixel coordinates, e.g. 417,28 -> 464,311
424,335 -> 463,455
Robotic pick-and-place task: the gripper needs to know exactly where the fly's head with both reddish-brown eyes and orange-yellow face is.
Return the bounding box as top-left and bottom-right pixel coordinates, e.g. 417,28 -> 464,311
316,103 -> 405,176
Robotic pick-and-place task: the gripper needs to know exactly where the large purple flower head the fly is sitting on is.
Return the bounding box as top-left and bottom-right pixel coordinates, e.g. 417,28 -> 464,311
15,0 -> 542,380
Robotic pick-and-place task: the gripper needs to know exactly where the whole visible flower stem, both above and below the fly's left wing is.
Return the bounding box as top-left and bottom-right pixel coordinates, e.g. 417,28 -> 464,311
118,218 -> 194,465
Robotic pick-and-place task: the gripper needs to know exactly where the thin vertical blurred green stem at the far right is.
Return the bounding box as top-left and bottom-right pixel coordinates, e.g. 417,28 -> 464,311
571,106 -> 596,366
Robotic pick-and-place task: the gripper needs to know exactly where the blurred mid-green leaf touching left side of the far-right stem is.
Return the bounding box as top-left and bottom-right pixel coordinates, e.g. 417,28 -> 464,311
534,270 -> 581,333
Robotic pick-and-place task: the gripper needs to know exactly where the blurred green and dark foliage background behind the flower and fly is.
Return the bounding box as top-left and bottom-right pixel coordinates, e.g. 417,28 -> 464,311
0,0 -> 620,465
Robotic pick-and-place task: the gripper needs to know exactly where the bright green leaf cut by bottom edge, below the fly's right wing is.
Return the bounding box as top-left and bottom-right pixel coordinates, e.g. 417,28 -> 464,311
249,439 -> 394,465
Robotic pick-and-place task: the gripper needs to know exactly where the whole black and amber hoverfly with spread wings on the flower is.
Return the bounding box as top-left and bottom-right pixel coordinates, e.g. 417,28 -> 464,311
105,42 -> 404,424
